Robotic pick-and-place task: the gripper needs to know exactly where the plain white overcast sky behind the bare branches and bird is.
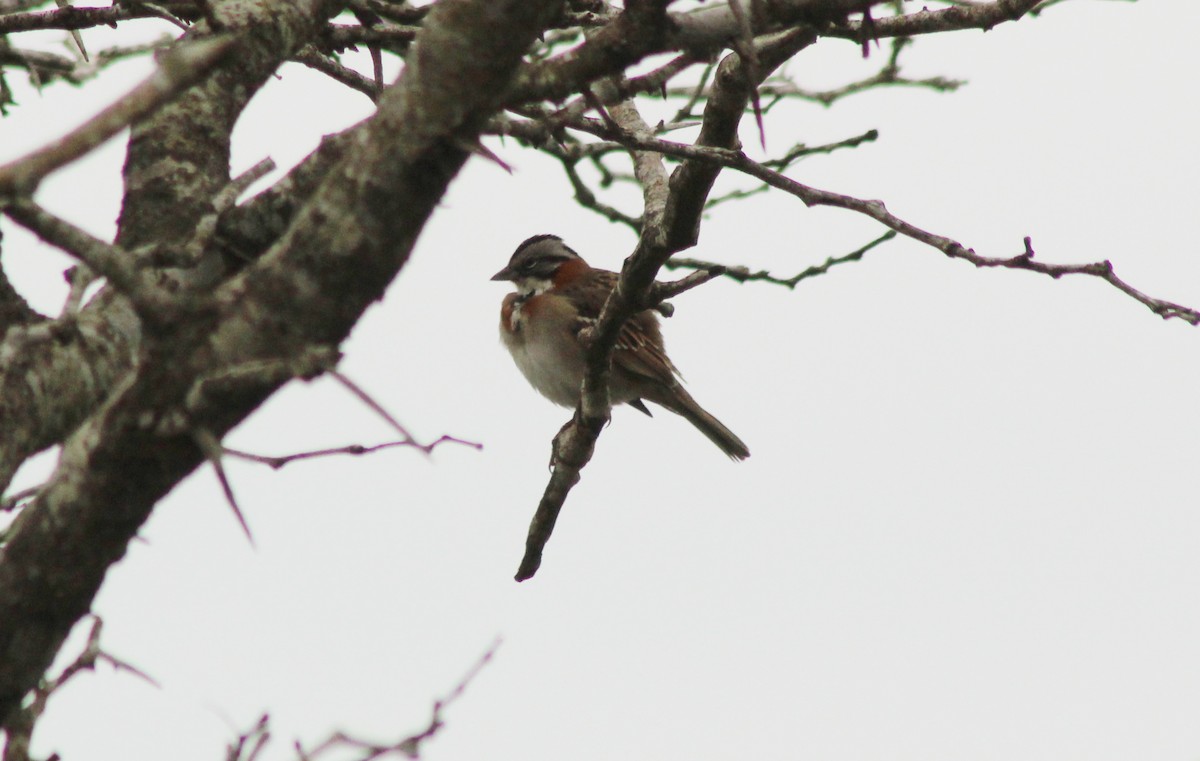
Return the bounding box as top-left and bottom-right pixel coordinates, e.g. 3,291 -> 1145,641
0,0 -> 1200,761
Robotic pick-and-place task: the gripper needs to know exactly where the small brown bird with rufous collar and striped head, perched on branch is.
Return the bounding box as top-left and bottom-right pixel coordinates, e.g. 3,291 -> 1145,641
492,234 -> 750,460
